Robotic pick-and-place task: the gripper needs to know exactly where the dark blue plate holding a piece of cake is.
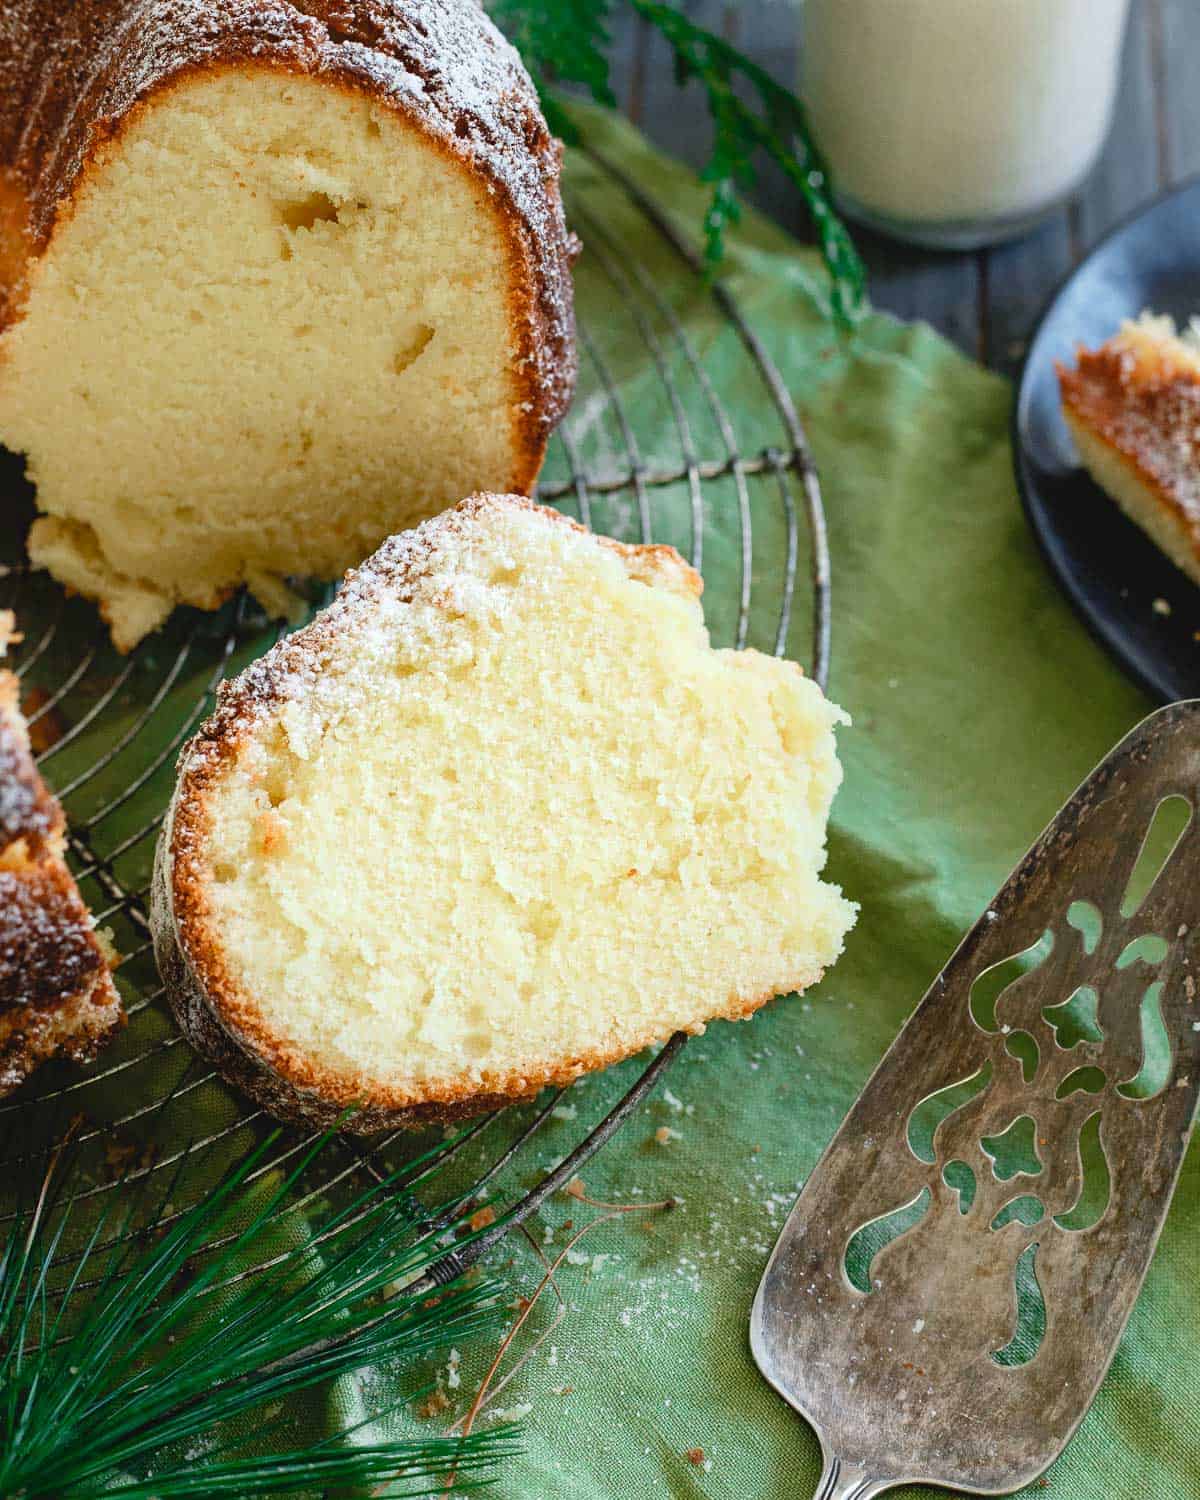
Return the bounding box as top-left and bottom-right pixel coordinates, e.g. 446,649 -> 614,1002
1013,179 -> 1200,702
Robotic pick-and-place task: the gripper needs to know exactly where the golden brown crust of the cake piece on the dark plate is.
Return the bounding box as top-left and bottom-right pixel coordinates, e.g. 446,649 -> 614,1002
1058,338 -> 1200,557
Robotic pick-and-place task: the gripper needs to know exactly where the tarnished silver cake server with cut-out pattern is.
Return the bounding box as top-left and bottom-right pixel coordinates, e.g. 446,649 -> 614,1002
750,701 -> 1200,1500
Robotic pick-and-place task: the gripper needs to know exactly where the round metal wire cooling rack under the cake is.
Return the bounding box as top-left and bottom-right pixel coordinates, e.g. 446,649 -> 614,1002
0,150 -> 830,1283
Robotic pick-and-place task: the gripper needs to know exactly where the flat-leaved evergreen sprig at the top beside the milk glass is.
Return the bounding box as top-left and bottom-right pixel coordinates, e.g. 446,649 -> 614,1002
489,0 -> 866,327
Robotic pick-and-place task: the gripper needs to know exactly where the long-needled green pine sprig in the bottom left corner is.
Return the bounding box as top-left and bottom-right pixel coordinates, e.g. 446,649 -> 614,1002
0,1133 -> 515,1500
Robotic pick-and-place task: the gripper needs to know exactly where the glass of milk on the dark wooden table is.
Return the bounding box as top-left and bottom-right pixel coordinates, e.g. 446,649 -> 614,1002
801,0 -> 1130,249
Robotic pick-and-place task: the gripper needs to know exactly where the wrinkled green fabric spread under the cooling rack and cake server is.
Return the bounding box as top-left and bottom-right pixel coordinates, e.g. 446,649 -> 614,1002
0,99 -> 1200,1500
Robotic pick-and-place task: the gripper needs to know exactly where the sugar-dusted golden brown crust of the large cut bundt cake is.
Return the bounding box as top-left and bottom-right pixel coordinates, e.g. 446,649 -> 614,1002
0,0 -> 576,456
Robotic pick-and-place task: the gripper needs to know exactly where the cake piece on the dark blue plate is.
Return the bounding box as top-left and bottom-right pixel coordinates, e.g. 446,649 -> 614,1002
1058,314 -> 1200,584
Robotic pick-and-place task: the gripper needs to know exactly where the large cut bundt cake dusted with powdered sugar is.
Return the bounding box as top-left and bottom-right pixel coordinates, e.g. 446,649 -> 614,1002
0,0 -> 575,650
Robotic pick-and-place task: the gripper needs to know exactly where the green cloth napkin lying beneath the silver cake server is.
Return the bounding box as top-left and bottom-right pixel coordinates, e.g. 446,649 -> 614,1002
405,111 -> 1200,1500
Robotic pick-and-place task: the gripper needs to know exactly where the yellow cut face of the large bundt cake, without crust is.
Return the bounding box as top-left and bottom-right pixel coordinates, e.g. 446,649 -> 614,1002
0,68 -> 521,648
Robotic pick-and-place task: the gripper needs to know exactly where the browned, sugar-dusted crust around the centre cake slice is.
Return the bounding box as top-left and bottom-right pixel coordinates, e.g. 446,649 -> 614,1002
152,495 -> 792,1134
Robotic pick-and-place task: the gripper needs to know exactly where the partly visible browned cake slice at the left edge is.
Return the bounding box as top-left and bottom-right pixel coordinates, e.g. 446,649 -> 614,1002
0,611 -> 123,1098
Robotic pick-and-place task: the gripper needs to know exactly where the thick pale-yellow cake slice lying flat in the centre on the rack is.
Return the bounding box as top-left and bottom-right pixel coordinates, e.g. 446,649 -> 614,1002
153,495 -> 855,1131
